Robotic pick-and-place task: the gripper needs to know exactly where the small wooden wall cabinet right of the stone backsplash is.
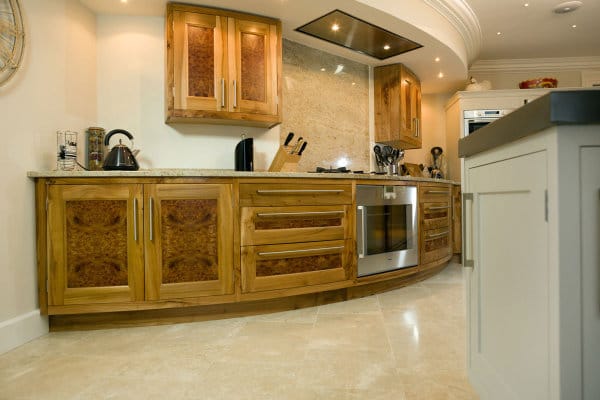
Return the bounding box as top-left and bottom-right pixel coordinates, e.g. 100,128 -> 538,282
374,64 -> 422,149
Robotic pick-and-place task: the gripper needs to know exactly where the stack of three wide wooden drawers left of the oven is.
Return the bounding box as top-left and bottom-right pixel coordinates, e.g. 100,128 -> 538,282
240,180 -> 353,293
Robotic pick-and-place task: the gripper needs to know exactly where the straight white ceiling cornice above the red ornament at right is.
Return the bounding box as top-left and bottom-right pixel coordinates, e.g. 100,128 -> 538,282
469,56 -> 600,72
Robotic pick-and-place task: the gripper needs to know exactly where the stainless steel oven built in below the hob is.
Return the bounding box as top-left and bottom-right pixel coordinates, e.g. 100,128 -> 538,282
356,185 -> 419,277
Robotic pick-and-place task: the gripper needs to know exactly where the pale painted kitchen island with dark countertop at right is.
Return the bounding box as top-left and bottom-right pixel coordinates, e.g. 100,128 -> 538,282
459,90 -> 600,400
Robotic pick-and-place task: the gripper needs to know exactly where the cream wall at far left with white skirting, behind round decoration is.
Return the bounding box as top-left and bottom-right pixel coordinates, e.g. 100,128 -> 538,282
0,0 -> 96,353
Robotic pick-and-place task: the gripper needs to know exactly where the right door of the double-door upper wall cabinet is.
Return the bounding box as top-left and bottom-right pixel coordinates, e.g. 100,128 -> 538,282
229,18 -> 278,115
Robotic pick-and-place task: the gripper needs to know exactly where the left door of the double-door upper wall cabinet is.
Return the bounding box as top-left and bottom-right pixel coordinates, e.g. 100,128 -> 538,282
172,11 -> 228,111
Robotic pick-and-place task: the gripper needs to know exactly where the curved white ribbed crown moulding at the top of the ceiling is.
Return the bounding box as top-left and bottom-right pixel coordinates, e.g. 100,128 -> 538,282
423,0 -> 482,65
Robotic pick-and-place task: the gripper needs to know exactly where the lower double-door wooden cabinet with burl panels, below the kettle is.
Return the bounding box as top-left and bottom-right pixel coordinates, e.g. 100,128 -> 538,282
46,183 -> 234,313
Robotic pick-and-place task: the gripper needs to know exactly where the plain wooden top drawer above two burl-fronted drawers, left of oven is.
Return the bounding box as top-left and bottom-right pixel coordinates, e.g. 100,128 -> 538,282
240,183 -> 352,207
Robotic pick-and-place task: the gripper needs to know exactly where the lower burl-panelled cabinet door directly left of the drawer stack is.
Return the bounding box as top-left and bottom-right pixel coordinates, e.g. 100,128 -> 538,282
144,184 -> 233,300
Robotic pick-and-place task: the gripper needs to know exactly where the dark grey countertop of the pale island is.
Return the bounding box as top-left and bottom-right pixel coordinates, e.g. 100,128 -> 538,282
458,89 -> 600,158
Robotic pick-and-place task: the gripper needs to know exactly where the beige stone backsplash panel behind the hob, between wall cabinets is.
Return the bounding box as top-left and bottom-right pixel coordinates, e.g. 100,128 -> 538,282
280,40 -> 370,172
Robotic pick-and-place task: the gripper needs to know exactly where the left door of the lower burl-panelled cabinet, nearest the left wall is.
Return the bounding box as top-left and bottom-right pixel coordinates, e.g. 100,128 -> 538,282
48,184 -> 144,306
